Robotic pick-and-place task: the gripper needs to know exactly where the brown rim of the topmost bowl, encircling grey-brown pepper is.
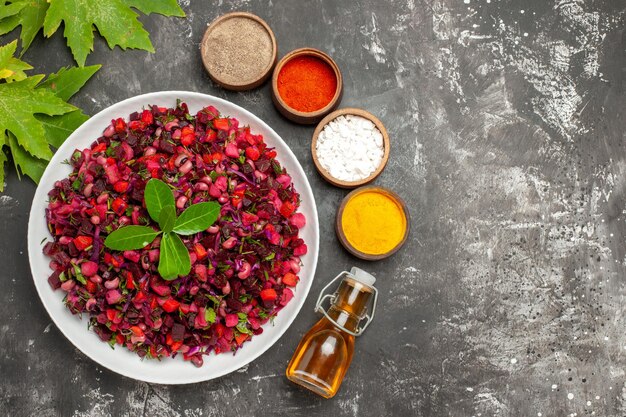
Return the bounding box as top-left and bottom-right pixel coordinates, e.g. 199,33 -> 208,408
200,12 -> 278,91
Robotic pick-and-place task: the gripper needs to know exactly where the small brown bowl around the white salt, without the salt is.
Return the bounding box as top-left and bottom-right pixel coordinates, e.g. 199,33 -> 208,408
311,107 -> 389,188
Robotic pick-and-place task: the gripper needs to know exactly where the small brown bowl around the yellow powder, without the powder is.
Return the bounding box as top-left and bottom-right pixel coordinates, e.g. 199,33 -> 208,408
335,186 -> 411,261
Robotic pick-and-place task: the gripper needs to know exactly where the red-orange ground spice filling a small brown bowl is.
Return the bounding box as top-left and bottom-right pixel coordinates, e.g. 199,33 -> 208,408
278,55 -> 337,113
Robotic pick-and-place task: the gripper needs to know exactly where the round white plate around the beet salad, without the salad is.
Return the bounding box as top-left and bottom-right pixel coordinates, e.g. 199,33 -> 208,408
28,91 -> 319,384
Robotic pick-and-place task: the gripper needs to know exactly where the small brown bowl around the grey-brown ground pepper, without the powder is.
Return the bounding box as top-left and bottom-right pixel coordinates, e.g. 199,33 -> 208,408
200,12 -> 278,91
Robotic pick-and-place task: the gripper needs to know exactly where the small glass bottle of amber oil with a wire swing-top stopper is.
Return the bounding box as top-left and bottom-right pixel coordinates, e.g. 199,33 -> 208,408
286,267 -> 378,398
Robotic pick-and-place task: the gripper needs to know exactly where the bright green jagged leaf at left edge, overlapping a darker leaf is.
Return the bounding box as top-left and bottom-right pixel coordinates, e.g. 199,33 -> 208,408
0,77 -> 76,160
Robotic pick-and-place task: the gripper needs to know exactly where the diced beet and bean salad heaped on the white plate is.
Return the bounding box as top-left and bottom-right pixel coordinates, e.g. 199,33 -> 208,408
43,103 -> 307,366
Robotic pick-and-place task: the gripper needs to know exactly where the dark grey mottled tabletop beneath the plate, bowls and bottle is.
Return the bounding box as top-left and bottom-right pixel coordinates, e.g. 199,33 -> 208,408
0,0 -> 626,417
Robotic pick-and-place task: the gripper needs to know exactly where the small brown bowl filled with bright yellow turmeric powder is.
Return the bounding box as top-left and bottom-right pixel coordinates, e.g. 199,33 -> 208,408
337,187 -> 409,260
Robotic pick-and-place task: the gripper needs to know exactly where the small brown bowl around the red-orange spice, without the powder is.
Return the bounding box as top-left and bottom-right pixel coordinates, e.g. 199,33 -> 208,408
272,48 -> 343,124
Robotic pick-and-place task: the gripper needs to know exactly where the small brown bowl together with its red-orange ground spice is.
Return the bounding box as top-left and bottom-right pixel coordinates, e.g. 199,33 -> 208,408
272,48 -> 343,124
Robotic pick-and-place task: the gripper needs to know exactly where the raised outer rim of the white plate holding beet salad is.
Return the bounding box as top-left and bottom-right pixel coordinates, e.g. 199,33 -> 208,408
27,90 -> 320,385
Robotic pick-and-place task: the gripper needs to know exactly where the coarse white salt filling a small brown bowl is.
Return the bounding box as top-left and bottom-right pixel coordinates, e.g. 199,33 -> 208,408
315,114 -> 385,182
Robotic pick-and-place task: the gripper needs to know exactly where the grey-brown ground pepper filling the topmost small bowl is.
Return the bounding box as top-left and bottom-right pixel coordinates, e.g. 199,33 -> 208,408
202,16 -> 275,86
